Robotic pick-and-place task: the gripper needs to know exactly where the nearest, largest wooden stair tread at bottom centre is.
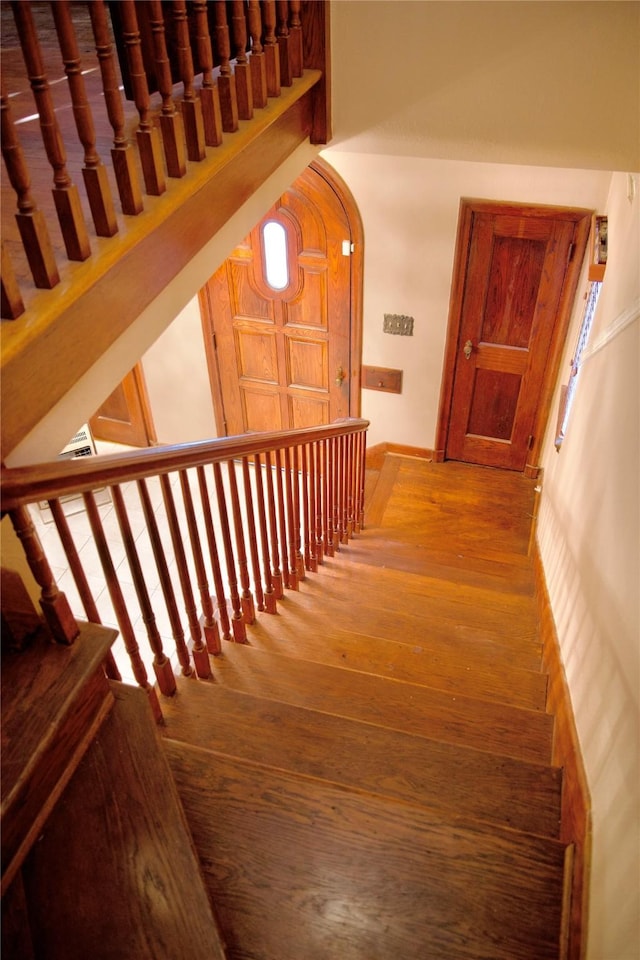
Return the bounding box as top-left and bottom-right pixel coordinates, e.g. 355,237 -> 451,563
165,740 -> 565,960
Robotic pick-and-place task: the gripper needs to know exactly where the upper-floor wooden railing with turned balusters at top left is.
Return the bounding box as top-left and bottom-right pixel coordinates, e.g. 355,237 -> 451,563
1,0 -> 328,319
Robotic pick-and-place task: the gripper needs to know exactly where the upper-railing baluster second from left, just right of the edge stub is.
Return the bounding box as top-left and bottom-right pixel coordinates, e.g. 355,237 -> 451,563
1,79 -> 60,288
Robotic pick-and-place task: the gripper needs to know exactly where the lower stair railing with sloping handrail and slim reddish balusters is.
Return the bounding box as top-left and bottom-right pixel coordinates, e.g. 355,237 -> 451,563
2,419 -> 368,716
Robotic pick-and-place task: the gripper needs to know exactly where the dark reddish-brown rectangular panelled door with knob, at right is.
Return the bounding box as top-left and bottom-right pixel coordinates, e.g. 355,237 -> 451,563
446,201 -> 589,471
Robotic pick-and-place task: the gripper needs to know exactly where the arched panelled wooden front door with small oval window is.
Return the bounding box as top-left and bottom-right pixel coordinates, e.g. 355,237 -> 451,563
200,162 -> 362,436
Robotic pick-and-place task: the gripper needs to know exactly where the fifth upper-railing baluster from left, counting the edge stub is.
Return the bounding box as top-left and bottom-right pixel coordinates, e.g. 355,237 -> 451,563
89,0 -> 143,216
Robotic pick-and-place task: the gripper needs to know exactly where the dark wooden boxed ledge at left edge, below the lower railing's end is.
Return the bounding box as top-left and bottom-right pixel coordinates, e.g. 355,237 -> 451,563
0,623 -> 117,891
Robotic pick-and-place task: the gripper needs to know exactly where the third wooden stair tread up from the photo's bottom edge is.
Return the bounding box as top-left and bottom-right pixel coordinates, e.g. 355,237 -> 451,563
214,643 -> 553,763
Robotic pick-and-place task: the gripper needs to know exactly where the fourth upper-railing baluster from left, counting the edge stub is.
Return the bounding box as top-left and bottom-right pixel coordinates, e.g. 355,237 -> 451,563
51,0 -> 118,237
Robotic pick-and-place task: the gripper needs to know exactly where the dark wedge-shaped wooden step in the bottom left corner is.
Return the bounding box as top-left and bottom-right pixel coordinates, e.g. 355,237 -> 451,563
23,684 -> 225,960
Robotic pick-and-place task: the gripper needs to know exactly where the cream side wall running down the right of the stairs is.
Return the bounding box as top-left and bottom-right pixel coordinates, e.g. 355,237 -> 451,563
538,174 -> 640,960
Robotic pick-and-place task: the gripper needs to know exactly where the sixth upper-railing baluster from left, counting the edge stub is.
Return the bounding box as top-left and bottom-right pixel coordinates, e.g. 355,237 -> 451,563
119,0 -> 167,197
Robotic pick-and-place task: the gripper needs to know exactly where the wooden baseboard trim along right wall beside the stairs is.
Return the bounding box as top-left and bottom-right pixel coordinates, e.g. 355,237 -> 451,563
532,542 -> 591,960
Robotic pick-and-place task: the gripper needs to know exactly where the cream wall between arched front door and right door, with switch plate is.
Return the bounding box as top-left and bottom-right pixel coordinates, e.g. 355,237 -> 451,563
322,148 -> 611,449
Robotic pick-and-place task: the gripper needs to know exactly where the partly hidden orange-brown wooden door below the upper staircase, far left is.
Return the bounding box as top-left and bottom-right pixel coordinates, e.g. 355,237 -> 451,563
89,364 -> 157,447
